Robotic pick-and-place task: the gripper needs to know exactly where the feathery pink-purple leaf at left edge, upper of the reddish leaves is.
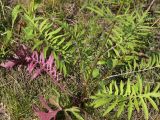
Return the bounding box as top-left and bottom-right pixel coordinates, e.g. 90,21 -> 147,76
0,45 -> 59,83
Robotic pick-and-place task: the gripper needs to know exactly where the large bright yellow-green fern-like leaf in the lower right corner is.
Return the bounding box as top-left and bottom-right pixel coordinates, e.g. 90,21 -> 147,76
91,75 -> 160,120
